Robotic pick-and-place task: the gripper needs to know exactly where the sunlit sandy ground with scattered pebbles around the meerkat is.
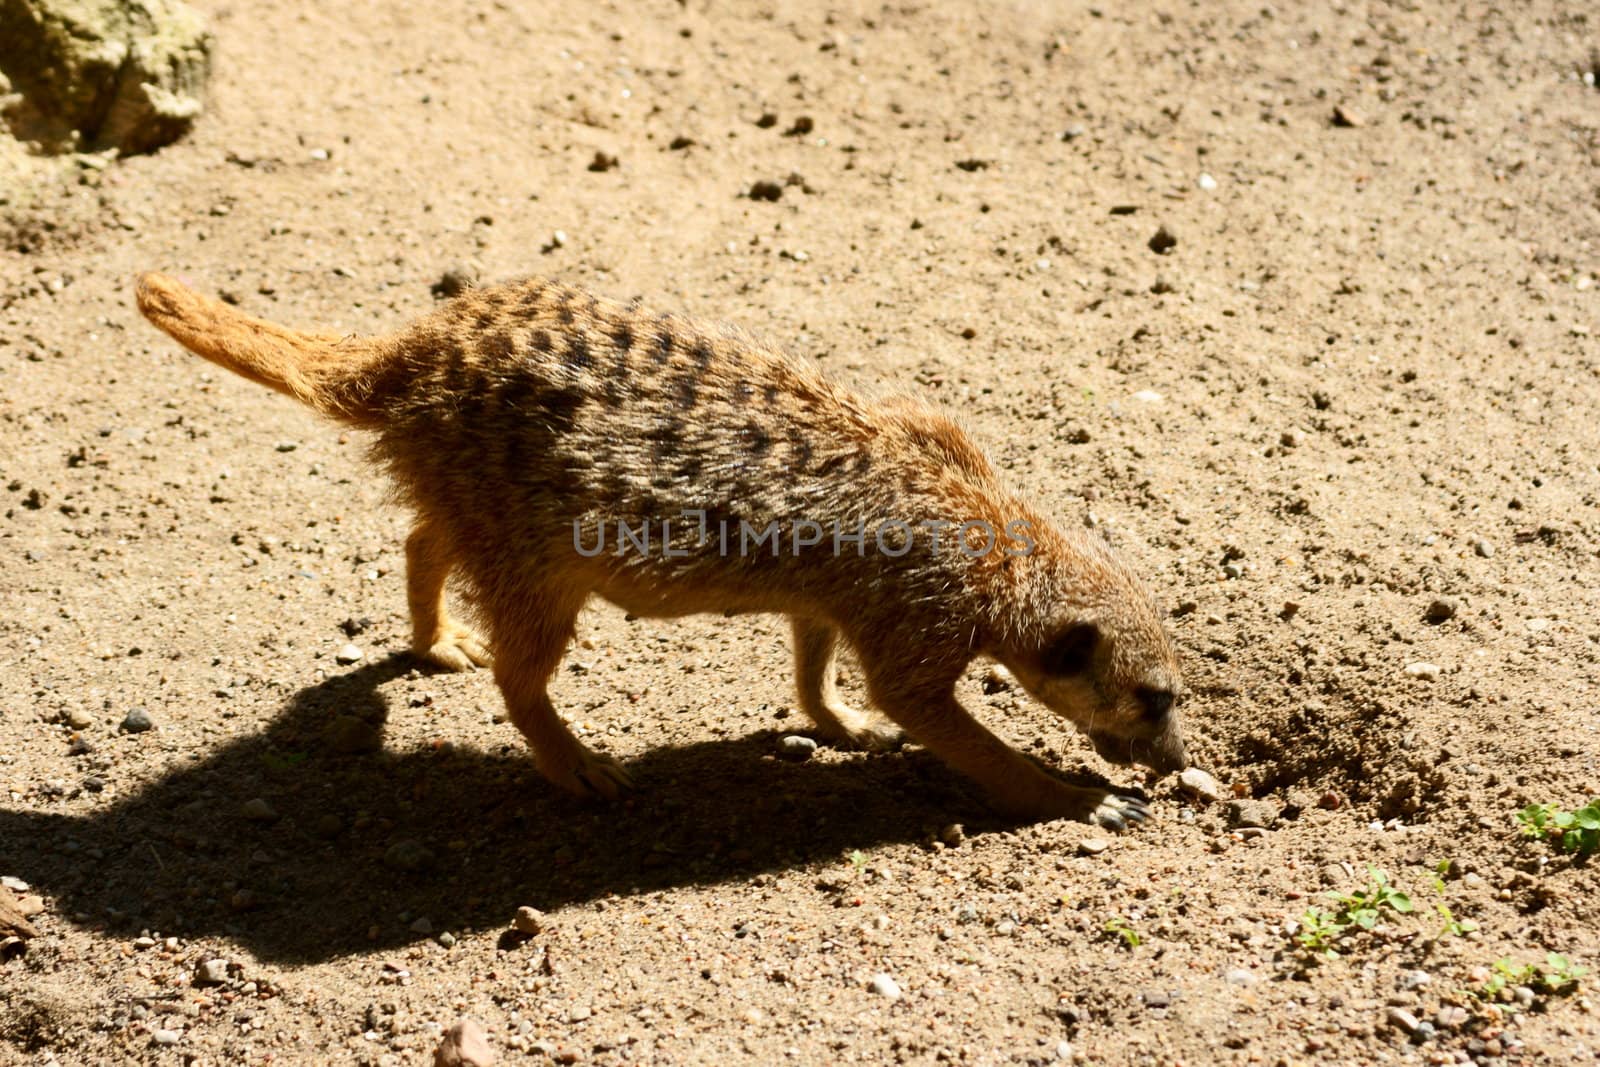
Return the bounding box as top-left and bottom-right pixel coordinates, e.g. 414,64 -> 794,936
0,0 -> 1600,1065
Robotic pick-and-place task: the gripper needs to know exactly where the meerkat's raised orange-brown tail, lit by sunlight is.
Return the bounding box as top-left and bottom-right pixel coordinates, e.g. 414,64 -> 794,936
138,274 -> 384,426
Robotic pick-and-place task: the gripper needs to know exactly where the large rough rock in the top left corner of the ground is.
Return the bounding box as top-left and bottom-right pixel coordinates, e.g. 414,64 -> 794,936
0,0 -> 211,155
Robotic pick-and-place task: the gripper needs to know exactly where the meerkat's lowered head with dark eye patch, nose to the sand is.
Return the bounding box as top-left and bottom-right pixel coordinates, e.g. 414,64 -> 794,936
992,524 -> 1189,774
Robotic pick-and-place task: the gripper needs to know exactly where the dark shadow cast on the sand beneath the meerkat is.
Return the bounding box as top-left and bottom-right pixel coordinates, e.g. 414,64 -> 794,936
0,657 -> 992,963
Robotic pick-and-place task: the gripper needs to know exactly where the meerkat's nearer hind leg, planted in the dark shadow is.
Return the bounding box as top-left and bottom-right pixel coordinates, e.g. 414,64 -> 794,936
491,597 -> 634,800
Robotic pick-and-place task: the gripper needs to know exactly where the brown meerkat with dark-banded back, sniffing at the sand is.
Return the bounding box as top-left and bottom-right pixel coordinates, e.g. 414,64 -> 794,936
138,274 -> 1187,829
